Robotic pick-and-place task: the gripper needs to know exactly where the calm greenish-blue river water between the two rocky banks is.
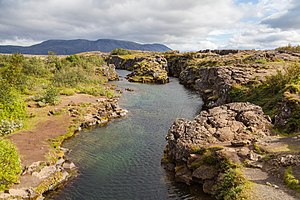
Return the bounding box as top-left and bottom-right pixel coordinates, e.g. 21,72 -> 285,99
50,71 -> 210,200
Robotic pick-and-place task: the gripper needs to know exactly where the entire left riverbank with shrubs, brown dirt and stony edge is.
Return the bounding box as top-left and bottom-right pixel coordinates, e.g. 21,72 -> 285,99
0,53 -> 127,199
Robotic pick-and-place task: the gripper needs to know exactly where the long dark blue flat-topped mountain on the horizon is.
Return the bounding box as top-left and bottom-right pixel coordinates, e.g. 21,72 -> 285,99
0,39 -> 171,55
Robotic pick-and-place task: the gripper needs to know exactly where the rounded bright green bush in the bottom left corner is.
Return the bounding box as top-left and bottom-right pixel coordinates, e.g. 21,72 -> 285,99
0,139 -> 22,191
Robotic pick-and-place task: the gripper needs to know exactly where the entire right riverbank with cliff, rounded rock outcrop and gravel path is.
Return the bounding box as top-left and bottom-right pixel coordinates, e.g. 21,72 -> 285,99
162,49 -> 300,199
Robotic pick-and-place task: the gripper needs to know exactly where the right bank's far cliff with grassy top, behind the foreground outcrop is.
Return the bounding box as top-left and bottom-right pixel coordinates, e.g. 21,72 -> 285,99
166,50 -> 299,108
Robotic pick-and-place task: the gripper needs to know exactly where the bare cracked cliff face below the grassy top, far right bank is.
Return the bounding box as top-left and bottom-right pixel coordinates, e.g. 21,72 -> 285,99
191,65 -> 276,108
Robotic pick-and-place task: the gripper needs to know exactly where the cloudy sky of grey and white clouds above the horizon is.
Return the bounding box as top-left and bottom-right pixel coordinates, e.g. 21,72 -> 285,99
0,0 -> 300,51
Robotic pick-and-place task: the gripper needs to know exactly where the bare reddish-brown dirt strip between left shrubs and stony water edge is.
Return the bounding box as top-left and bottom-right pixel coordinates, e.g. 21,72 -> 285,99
8,94 -> 98,189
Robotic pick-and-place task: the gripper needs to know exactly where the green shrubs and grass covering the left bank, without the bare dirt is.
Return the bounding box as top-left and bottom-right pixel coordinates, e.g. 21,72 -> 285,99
0,54 -> 117,191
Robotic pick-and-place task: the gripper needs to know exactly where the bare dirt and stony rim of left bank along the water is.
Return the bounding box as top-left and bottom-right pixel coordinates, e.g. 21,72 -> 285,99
0,94 -> 127,199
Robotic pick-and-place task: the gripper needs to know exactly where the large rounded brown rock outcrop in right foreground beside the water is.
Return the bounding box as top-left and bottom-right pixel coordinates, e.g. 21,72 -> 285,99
162,103 -> 272,195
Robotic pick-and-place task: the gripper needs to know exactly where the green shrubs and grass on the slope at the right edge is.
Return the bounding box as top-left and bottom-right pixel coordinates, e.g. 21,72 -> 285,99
229,64 -> 300,133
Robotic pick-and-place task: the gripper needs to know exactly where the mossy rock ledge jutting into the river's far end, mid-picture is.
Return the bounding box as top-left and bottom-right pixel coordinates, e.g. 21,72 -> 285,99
107,54 -> 169,84
